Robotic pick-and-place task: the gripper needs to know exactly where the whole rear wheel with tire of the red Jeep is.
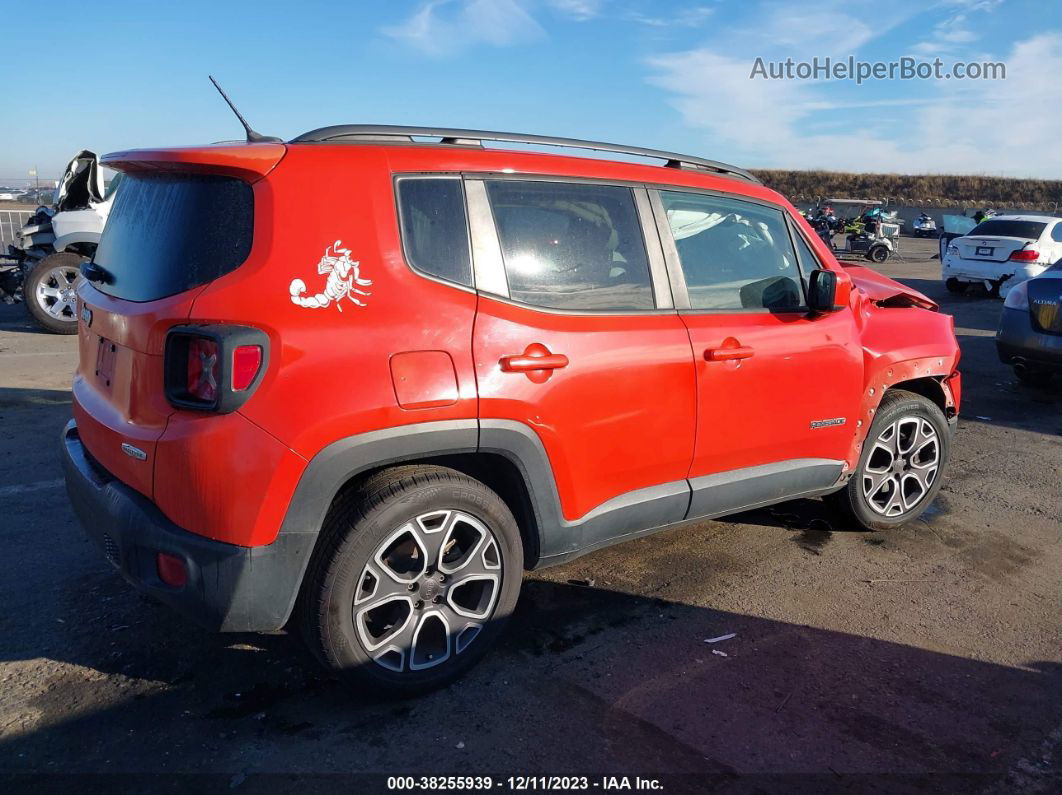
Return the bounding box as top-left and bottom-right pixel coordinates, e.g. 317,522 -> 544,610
299,465 -> 524,697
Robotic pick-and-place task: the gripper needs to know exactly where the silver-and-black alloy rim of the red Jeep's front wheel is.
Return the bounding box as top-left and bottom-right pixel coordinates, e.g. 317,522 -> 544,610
861,416 -> 941,517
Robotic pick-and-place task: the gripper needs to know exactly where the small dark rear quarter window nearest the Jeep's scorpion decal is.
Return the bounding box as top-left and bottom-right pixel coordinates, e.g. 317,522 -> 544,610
398,177 -> 472,287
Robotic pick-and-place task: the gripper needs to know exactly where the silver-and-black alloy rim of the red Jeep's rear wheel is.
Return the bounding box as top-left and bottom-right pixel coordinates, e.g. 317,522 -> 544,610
353,511 -> 501,673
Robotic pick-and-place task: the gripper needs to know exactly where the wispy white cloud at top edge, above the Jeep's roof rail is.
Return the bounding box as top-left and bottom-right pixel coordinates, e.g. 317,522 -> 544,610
381,0 -> 544,56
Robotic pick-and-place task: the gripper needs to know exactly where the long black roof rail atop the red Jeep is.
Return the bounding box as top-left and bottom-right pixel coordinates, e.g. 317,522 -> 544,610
290,124 -> 763,185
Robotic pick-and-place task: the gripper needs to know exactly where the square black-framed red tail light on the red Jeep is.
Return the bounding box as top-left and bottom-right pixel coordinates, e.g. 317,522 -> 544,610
165,325 -> 269,414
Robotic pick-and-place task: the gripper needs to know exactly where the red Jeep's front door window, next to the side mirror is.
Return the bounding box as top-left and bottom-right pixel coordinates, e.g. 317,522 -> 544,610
661,191 -> 798,311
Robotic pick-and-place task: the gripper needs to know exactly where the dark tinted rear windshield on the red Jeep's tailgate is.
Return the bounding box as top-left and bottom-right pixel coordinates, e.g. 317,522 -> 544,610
93,174 -> 254,301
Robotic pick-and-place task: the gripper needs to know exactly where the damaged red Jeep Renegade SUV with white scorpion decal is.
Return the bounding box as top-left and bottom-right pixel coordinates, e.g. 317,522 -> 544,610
63,125 -> 960,692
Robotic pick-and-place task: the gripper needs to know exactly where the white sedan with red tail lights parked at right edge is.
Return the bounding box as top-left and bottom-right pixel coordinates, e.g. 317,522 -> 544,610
941,215 -> 1062,297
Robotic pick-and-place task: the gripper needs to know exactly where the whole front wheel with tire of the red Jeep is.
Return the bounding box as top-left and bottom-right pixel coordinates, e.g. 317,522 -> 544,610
829,390 -> 952,530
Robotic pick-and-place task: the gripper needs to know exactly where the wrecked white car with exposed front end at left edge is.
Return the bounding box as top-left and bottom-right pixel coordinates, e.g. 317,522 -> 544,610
2,150 -> 120,334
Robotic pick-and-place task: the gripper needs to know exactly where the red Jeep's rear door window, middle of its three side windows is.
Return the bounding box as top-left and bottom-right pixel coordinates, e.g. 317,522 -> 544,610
486,179 -> 655,312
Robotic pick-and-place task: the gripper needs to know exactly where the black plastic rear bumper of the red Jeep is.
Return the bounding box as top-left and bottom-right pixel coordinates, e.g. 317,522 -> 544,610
63,420 -> 315,632
